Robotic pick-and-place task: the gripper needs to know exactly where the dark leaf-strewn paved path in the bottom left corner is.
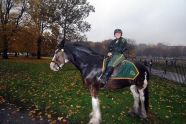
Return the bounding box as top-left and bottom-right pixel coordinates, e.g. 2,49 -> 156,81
0,96 -> 69,124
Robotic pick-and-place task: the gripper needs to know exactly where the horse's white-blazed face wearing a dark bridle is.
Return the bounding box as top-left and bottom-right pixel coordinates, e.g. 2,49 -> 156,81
50,49 -> 68,71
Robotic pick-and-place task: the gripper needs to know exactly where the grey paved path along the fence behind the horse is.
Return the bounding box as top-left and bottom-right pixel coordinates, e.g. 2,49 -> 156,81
151,69 -> 186,84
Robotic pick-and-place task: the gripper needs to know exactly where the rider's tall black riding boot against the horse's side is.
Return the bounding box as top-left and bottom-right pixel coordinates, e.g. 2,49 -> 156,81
101,66 -> 114,85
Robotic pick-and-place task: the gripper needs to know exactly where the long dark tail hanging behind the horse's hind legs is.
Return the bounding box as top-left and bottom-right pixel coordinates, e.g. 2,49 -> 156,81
144,71 -> 149,112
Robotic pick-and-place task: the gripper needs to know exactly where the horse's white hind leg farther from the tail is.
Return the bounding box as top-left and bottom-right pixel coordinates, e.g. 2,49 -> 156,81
129,85 -> 140,116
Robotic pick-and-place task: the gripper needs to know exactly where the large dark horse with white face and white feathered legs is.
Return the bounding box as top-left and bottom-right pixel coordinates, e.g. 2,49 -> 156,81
50,42 -> 149,124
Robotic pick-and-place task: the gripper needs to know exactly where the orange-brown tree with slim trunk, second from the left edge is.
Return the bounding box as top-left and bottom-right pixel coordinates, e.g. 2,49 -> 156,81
27,0 -> 50,59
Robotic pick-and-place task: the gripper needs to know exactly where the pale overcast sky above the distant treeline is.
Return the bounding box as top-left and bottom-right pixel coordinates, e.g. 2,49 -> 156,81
86,0 -> 186,46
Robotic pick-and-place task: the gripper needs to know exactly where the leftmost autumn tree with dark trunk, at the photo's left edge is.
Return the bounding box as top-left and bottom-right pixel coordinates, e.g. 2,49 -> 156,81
0,0 -> 26,59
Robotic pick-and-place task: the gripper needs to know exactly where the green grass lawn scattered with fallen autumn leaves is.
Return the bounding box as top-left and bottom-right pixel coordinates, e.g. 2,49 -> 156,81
0,59 -> 186,124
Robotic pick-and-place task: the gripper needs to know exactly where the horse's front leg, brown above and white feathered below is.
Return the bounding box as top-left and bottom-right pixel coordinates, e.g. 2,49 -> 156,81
89,87 -> 101,124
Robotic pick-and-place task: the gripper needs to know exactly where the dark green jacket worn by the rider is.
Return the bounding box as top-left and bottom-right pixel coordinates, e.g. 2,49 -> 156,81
108,37 -> 127,54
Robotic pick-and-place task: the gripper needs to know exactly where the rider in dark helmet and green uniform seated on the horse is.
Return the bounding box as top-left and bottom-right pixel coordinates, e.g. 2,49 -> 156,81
101,29 -> 127,84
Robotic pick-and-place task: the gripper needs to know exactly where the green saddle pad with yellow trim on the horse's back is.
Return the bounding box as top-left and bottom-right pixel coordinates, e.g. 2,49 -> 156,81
111,60 -> 139,80
